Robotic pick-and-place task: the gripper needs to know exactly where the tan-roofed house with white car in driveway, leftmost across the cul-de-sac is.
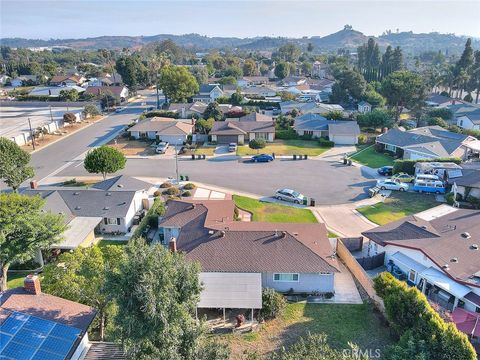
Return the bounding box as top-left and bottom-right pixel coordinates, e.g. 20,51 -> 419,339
128,116 -> 195,145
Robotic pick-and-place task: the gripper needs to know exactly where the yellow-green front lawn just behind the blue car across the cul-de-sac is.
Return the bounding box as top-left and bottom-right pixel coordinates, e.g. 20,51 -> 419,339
237,140 -> 330,156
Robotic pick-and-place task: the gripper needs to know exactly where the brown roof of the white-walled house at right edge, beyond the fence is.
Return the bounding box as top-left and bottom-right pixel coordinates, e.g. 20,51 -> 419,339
362,209 -> 480,286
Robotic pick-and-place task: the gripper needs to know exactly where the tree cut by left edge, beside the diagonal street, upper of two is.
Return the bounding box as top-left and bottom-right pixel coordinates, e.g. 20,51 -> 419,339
0,137 -> 35,192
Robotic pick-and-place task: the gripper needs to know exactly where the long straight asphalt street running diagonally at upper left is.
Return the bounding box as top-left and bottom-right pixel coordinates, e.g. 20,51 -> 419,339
0,91 -> 160,190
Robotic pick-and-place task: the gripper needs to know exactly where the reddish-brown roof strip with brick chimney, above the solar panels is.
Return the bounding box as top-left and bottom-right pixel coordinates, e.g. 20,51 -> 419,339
0,287 -> 96,333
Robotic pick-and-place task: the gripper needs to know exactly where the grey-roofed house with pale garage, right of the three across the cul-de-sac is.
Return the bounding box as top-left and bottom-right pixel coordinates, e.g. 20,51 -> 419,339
293,113 -> 360,145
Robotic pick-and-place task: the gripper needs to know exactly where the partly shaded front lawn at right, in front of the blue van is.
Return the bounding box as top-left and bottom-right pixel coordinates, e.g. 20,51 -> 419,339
357,191 -> 439,225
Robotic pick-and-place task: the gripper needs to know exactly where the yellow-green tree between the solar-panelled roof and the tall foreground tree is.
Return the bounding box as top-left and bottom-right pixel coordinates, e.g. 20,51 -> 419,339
42,245 -> 124,341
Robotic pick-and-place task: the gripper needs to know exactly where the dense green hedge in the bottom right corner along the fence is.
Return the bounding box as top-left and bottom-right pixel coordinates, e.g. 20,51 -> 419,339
374,272 -> 477,360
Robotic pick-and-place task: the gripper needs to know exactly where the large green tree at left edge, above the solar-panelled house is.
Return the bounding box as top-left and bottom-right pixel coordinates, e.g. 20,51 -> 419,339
0,193 -> 66,293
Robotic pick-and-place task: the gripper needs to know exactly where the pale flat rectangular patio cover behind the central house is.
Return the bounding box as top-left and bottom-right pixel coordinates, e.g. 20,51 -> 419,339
197,272 -> 262,309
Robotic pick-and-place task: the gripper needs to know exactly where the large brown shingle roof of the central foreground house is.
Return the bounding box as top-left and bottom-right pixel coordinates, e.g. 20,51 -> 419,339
159,200 -> 338,272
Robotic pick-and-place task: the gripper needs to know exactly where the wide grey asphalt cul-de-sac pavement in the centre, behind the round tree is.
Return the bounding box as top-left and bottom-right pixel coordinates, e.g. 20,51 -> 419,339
57,156 -> 375,205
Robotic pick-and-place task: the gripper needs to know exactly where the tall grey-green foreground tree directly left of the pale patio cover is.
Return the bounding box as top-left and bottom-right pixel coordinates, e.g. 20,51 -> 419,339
109,239 -> 225,360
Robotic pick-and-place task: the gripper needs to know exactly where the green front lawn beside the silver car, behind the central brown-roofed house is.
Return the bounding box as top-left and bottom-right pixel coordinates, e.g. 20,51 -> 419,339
233,195 -> 318,223
